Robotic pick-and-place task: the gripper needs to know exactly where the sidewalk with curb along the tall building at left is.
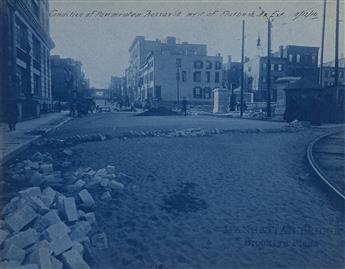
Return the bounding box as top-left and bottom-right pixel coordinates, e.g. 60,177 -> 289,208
0,111 -> 71,164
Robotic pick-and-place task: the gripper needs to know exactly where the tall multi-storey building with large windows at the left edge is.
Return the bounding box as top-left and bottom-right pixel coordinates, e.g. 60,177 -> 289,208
0,0 -> 54,120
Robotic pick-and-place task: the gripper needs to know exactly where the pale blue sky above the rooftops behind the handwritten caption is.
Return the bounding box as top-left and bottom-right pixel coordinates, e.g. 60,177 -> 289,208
50,0 -> 344,88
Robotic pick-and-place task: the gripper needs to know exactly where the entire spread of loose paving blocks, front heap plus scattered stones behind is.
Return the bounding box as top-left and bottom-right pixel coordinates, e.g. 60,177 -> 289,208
0,150 -> 133,269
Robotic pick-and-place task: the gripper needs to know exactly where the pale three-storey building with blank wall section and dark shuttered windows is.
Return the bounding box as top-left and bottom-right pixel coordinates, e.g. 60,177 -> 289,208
139,50 -> 223,104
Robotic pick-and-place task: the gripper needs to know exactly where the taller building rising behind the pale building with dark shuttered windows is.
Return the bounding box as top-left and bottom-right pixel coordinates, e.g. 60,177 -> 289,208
126,36 -> 207,99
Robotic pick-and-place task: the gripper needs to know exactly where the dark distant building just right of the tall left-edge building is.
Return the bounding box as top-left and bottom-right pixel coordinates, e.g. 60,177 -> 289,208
50,55 -> 89,102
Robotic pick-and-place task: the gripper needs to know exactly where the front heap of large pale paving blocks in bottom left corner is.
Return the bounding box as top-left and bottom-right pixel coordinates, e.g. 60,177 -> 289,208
0,184 -> 96,269
